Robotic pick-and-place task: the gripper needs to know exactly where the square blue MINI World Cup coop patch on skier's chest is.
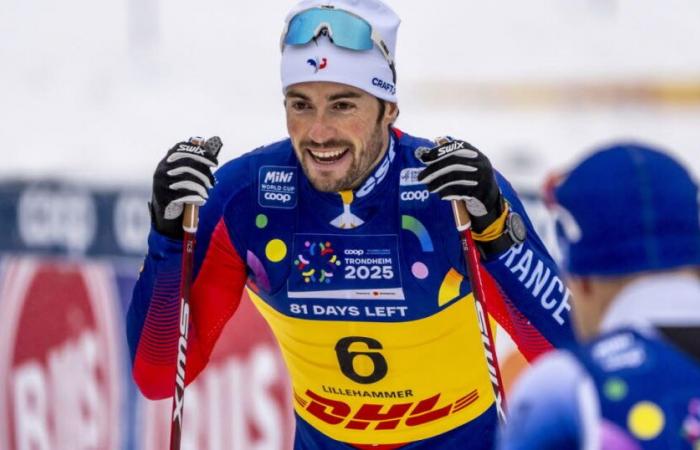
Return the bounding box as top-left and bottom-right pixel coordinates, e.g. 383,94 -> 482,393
258,166 -> 297,209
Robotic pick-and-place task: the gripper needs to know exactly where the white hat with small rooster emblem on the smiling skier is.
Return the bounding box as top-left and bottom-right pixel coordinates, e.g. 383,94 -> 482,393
281,0 -> 401,103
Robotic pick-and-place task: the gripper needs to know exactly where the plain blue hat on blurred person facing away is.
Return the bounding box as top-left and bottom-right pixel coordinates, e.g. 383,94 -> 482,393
553,143 -> 700,275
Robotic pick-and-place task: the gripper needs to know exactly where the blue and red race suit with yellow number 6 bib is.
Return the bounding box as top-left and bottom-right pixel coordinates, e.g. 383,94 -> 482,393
128,129 -> 573,449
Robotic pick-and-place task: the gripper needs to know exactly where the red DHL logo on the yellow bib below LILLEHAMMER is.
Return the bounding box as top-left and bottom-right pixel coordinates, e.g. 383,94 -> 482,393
294,389 -> 479,430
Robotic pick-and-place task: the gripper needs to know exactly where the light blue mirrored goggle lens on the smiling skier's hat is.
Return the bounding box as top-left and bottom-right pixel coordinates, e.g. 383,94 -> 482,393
284,9 -> 374,50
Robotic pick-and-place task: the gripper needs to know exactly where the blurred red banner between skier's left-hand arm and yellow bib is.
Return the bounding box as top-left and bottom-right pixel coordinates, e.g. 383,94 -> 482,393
141,296 -> 294,450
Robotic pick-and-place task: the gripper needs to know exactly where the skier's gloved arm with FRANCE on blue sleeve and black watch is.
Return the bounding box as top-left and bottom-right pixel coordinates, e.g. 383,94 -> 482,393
418,140 -> 573,360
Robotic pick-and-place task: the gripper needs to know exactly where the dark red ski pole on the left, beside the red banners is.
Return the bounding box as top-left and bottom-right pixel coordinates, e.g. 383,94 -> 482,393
170,136 -> 222,450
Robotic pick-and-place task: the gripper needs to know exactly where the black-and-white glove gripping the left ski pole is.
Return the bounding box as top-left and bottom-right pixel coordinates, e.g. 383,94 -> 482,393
149,136 -> 223,239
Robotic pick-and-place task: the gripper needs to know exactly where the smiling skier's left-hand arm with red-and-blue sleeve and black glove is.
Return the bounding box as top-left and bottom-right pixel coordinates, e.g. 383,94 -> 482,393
127,139 -> 246,398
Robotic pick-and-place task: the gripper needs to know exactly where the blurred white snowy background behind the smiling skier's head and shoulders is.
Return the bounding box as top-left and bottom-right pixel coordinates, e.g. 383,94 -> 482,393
0,0 -> 700,186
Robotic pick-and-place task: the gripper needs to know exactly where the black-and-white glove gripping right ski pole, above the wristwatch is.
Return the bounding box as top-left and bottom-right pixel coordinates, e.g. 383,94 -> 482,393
416,139 -> 504,233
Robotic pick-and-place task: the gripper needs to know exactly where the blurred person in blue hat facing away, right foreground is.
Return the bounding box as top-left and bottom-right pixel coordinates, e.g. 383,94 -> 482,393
498,143 -> 700,450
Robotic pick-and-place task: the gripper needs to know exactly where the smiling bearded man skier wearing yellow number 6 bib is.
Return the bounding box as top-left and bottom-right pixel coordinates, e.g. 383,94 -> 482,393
128,0 -> 573,450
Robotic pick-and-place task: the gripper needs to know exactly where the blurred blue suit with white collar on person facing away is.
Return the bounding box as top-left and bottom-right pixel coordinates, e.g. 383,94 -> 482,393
498,275 -> 700,450
